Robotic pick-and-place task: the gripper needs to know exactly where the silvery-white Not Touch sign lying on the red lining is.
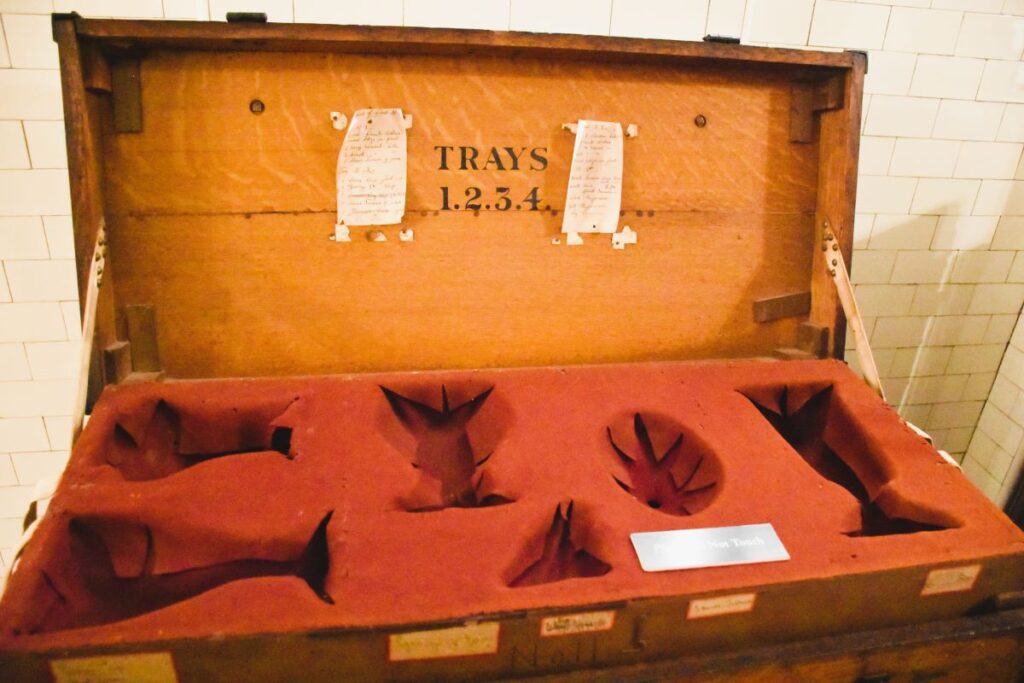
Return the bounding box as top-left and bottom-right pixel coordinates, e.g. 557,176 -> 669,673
630,524 -> 790,571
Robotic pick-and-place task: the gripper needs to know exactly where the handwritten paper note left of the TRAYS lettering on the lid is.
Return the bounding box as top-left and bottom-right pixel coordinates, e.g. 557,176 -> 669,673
338,109 -> 407,225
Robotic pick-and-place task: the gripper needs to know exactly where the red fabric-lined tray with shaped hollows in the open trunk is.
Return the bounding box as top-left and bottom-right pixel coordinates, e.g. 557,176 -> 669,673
0,361 -> 1024,648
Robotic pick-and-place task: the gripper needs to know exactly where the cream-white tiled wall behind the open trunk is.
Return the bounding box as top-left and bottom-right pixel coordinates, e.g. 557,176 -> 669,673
0,0 -> 1024,563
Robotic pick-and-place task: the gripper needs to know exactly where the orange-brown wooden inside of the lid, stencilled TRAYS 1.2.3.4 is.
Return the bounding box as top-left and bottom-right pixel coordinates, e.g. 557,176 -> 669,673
66,20 -> 862,382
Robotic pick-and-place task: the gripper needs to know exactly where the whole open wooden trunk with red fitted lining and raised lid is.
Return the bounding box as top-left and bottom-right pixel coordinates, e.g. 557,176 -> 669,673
0,15 -> 1024,681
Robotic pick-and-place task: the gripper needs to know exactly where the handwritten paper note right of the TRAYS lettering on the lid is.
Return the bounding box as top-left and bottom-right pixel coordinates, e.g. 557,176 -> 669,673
562,120 -> 623,233
